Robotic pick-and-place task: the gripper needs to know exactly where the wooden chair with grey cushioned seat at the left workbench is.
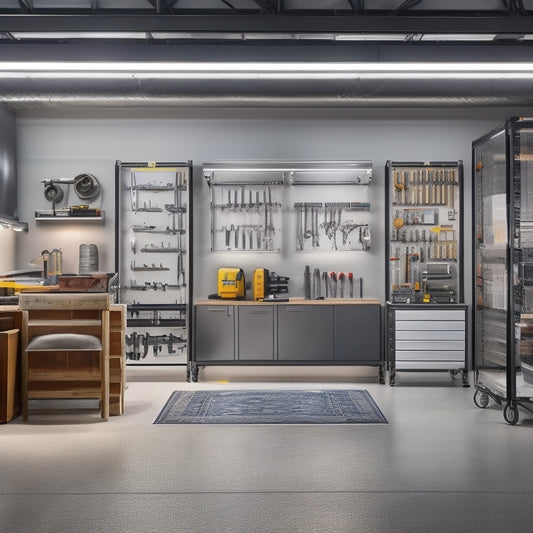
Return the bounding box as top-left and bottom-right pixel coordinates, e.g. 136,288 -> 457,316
19,293 -> 109,420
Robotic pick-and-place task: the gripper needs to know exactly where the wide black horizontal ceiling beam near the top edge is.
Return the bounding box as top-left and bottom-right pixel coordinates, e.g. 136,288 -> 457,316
0,14 -> 533,34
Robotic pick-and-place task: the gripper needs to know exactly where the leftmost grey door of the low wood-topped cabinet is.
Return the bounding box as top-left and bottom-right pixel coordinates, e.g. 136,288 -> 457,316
195,305 -> 235,361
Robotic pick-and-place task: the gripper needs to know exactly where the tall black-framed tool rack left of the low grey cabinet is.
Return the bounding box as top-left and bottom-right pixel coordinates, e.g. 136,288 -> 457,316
115,161 -> 192,365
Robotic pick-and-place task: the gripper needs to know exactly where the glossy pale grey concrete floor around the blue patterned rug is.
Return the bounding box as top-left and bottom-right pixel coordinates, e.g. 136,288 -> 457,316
0,367 -> 533,533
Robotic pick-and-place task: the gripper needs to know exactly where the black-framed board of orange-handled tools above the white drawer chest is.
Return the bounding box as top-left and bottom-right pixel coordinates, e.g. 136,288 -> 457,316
386,161 -> 463,304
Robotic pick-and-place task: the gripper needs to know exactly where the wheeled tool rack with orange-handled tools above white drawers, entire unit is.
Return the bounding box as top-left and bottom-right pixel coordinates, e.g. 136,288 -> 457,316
385,161 -> 469,386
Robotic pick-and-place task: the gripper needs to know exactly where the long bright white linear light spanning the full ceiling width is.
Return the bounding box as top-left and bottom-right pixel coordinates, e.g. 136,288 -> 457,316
0,61 -> 533,80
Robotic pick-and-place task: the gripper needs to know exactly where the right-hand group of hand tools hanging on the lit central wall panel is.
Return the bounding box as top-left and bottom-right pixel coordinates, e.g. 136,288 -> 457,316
294,202 -> 371,251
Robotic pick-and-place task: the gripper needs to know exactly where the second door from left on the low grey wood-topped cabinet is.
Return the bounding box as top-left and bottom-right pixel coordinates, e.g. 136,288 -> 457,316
238,304 -> 274,361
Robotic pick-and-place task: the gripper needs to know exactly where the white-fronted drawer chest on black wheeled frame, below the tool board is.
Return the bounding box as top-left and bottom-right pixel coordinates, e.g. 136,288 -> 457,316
387,304 -> 468,386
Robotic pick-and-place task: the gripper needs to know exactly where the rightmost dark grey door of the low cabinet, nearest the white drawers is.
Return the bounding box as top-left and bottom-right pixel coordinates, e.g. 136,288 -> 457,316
334,305 -> 381,363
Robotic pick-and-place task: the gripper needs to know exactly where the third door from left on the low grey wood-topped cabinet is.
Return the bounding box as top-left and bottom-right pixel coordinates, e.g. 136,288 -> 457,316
277,305 -> 333,361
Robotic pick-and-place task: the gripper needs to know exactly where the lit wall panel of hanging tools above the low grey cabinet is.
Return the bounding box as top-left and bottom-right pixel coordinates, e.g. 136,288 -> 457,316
204,161 -> 372,252
